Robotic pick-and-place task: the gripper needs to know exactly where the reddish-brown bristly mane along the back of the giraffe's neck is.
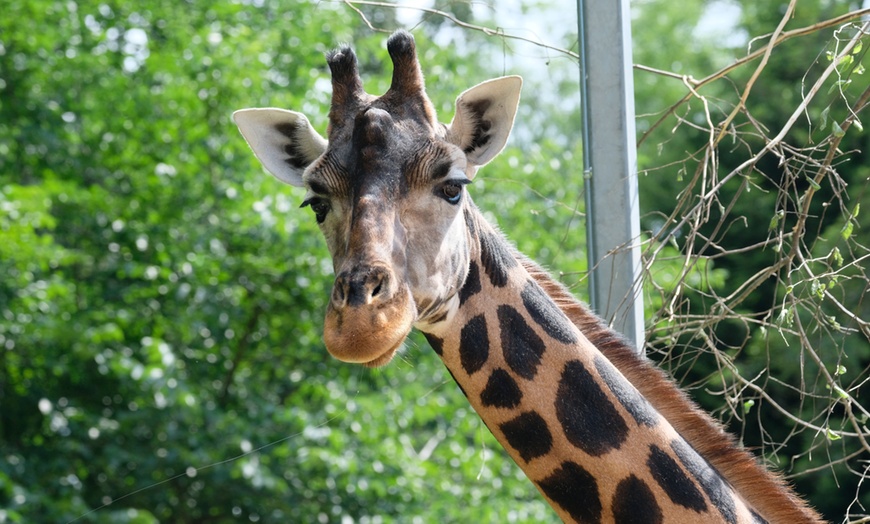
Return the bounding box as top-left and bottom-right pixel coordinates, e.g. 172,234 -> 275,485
514,251 -> 821,522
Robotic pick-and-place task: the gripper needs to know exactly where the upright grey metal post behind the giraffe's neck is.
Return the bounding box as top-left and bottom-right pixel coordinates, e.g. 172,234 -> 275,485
577,0 -> 644,351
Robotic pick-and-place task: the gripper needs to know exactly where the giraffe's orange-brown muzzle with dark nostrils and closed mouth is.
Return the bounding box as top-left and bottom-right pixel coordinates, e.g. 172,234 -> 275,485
324,265 -> 416,367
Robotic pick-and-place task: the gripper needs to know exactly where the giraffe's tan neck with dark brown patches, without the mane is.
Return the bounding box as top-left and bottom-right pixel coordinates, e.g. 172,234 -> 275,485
423,205 -> 820,523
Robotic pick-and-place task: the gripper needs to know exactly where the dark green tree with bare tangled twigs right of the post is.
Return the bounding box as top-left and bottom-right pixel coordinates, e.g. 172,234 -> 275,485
637,1 -> 870,520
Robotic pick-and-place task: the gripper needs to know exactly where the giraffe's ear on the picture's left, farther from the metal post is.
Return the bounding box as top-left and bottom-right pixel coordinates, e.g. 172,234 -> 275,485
233,108 -> 326,187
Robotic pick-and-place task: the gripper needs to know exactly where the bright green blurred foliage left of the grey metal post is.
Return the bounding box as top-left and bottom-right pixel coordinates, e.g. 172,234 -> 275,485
0,0 -> 583,523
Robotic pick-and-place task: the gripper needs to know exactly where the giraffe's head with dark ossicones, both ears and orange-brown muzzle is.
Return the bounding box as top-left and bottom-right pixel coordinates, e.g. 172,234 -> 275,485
233,31 -> 522,366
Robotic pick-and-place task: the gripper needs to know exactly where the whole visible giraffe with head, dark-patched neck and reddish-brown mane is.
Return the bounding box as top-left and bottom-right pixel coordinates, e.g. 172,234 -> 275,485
233,31 -> 822,523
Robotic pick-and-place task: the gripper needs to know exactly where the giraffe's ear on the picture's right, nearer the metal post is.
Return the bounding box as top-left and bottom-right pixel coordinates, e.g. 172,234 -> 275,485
447,76 -> 523,172
